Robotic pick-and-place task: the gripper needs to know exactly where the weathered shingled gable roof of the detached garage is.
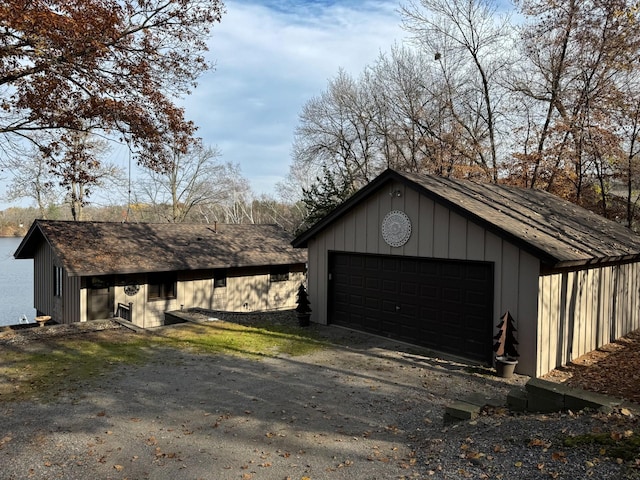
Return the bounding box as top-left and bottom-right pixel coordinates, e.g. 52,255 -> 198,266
293,170 -> 640,269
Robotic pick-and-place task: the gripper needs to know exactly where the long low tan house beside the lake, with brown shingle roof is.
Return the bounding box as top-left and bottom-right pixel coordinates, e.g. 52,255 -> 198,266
14,220 -> 307,328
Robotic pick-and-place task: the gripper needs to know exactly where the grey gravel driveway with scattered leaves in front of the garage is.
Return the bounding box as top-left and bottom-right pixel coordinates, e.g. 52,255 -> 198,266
0,318 -> 640,480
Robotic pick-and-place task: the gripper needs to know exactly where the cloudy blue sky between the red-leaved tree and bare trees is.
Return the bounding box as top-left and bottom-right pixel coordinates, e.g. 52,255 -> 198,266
185,0 -> 404,197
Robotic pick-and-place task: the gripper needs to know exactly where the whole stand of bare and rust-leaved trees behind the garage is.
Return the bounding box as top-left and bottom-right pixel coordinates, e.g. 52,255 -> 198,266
282,0 -> 640,231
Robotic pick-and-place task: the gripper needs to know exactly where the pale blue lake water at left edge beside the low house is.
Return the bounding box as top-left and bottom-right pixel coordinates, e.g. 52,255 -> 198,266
0,238 -> 36,325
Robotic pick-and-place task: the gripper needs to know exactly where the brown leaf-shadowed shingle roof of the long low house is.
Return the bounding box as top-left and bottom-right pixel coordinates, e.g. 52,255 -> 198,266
14,220 -> 307,276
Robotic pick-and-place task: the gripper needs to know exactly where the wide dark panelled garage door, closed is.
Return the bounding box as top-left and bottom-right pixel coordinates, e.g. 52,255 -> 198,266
329,252 -> 493,362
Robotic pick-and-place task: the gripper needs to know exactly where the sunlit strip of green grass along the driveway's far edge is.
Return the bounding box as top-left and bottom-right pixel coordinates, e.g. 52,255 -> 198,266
0,321 -> 327,402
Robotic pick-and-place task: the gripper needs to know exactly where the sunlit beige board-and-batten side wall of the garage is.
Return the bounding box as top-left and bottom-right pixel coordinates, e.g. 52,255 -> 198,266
536,263 -> 640,376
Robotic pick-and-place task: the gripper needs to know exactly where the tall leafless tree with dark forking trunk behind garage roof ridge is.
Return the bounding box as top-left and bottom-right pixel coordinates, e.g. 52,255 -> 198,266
401,0 -> 511,182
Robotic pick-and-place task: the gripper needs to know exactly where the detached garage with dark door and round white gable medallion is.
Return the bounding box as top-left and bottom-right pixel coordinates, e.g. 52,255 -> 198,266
293,170 -> 640,376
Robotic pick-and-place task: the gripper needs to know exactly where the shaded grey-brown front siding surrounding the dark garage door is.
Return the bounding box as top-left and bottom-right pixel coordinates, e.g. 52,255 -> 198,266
308,182 -> 540,375
